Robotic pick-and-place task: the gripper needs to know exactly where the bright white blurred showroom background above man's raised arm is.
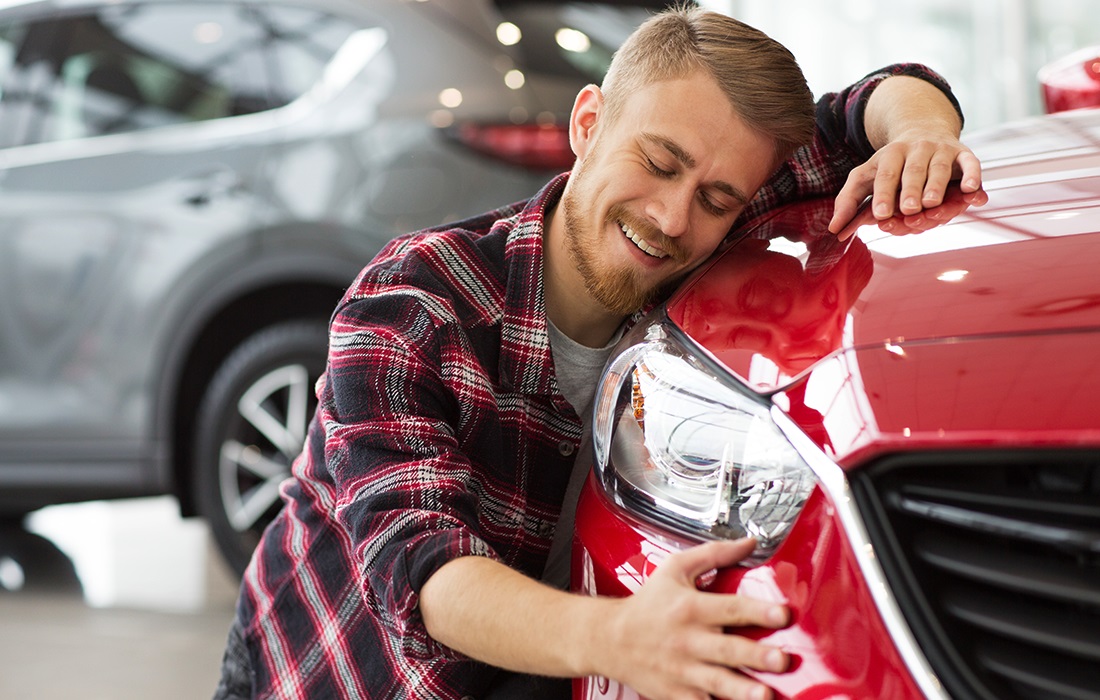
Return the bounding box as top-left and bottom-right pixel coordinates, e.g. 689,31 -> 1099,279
712,0 -> 1100,130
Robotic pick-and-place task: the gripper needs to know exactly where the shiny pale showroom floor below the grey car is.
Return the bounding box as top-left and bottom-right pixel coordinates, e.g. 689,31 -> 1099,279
0,499 -> 237,700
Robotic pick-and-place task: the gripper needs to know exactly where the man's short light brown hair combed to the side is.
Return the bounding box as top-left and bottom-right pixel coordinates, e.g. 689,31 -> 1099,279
602,6 -> 814,166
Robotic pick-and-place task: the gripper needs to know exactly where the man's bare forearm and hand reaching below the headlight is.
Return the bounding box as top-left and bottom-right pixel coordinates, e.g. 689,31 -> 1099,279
420,539 -> 789,700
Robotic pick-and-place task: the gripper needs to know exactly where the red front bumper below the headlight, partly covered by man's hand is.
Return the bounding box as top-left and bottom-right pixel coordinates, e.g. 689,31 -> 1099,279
573,477 -> 923,700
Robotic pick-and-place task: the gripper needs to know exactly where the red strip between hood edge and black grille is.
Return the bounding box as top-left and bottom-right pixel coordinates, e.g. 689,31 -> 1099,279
774,330 -> 1100,466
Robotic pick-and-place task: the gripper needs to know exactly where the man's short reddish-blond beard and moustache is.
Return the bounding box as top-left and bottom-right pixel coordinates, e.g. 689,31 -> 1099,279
559,157 -> 688,316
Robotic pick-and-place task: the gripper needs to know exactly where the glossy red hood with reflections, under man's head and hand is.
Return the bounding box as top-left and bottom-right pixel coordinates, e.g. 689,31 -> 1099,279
668,111 -> 1100,393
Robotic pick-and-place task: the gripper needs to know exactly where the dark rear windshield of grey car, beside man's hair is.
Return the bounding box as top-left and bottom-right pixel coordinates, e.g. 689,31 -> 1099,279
496,0 -> 662,83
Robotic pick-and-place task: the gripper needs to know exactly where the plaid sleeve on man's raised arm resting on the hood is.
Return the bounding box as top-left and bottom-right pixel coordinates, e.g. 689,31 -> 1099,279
734,64 -> 963,230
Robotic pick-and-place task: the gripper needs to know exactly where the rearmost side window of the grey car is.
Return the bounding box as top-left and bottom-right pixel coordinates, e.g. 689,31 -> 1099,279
259,7 -> 360,105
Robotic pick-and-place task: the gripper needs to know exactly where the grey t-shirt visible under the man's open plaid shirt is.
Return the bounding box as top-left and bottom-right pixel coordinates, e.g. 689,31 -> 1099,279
542,319 -> 623,589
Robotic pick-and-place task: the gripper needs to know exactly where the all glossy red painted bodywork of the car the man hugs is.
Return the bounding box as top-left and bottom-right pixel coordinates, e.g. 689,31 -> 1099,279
573,106 -> 1100,700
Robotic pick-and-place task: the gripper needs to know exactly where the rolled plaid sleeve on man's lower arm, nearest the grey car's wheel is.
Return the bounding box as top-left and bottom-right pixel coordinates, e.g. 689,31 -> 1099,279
312,276 -> 499,659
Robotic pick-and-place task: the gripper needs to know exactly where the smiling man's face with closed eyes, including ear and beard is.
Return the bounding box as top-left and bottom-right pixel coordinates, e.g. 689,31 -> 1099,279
560,73 -> 774,315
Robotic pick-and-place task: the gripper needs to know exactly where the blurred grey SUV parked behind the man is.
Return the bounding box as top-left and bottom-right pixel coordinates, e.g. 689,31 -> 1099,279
0,0 -> 661,570
